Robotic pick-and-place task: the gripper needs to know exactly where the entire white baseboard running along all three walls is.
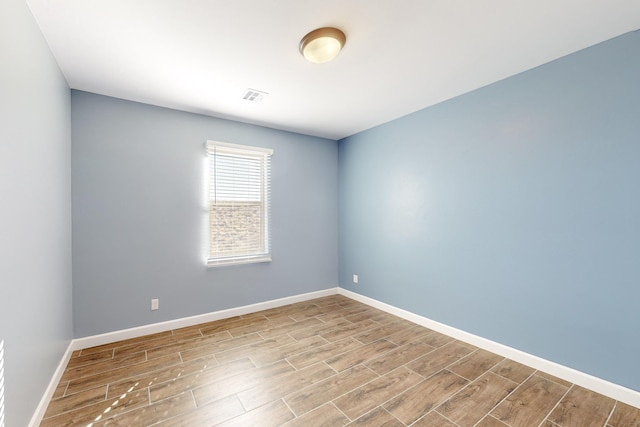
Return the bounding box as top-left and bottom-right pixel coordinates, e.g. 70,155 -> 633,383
29,287 -> 640,427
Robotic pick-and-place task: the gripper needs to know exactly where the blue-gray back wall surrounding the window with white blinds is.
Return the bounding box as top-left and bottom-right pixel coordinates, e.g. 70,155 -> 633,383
71,90 -> 338,337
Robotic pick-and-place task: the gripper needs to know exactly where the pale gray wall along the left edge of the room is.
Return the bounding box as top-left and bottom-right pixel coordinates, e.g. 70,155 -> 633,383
0,0 -> 72,427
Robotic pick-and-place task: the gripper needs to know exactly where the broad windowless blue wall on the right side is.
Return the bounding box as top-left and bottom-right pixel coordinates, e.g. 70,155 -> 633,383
339,32 -> 640,390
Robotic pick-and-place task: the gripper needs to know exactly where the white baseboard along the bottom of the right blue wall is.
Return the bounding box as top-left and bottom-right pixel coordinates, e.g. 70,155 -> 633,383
338,288 -> 640,408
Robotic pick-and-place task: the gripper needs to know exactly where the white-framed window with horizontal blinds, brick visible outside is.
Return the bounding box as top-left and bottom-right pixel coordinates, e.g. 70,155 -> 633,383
206,141 -> 273,266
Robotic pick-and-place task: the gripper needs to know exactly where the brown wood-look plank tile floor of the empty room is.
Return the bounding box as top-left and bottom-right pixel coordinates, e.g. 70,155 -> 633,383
40,295 -> 640,427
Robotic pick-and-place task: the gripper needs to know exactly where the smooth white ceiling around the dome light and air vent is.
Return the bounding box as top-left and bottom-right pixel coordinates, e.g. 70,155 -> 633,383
28,0 -> 640,139
